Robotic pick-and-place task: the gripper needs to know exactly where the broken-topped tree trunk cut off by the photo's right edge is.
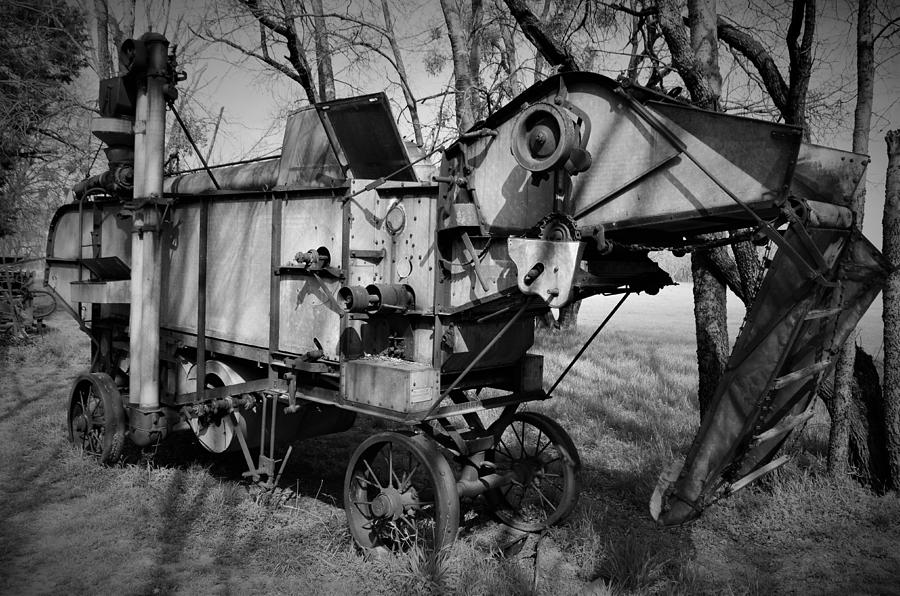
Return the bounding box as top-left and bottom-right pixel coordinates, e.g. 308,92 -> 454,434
882,130 -> 900,490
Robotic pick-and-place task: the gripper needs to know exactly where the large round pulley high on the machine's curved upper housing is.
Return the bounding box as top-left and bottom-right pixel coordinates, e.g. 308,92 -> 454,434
511,102 -> 578,172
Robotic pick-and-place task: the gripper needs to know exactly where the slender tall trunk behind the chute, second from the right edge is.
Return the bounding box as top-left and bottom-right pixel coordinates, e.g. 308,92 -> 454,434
828,0 -> 875,476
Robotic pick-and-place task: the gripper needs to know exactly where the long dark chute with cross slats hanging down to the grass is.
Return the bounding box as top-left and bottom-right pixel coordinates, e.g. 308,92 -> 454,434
651,217 -> 890,525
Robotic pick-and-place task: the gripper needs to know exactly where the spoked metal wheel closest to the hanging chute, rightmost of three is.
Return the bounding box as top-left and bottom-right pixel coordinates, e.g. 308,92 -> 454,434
485,412 -> 581,532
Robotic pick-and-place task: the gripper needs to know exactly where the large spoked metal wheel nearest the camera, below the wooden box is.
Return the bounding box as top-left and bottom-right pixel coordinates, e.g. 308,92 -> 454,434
344,432 -> 459,552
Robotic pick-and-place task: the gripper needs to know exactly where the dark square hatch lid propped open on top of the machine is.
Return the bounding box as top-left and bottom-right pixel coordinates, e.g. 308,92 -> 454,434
316,93 -> 417,182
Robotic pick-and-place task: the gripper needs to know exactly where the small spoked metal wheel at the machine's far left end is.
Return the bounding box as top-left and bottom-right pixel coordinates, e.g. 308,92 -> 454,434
69,373 -> 125,464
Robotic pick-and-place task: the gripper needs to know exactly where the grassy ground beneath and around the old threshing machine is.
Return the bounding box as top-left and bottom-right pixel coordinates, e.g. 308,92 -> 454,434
0,294 -> 900,594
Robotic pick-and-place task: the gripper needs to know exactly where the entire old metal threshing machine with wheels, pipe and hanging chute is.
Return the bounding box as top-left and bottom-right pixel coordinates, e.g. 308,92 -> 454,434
47,34 -> 886,548
